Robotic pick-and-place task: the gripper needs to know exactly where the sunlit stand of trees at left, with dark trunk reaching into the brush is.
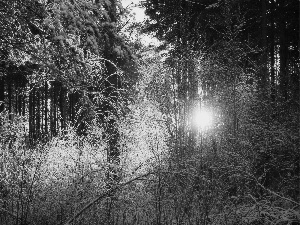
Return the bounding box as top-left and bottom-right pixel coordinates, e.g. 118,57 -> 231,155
0,0 -> 131,223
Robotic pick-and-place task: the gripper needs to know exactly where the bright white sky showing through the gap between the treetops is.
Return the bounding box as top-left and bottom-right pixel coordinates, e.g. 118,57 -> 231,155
121,0 -> 160,46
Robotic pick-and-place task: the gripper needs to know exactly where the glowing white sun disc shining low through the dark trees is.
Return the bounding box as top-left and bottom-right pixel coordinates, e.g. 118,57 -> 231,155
193,108 -> 213,130
